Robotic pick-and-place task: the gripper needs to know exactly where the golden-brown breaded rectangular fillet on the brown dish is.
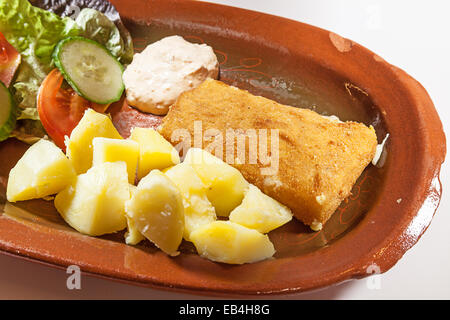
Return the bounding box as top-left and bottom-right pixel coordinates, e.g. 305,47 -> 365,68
160,79 -> 377,229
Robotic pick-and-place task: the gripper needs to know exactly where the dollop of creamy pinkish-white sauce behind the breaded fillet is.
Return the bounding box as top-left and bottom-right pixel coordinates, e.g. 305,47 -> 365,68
123,36 -> 219,115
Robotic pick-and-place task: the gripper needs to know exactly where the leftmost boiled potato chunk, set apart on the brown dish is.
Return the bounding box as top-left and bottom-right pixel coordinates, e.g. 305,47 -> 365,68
6,139 -> 76,202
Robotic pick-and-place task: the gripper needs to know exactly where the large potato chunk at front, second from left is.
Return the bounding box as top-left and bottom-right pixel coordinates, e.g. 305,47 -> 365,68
55,162 -> 131,236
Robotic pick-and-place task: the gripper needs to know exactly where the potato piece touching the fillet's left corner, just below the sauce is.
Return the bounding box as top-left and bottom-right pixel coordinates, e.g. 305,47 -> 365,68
130,128 -> 180,179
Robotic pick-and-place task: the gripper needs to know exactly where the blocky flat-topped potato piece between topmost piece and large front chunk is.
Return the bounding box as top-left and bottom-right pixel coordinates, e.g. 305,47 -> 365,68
92,137 -> 139,184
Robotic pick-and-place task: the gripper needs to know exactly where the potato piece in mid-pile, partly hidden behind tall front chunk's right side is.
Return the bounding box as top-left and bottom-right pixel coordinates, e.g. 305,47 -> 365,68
165,163 -> 217,241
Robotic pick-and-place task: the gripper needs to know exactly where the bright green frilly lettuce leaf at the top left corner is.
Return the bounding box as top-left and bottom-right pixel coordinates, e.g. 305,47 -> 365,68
0,0 -> 81,109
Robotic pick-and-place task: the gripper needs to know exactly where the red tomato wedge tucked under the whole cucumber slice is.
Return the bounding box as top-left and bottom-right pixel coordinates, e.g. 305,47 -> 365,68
37,69 -> 109,151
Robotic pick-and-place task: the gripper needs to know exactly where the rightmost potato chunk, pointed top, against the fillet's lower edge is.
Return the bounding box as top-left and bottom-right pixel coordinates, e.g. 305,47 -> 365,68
230,184 -> 292,233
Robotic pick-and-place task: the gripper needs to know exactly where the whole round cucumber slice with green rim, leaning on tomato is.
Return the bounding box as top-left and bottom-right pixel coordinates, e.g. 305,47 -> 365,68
53,37 -> 125,104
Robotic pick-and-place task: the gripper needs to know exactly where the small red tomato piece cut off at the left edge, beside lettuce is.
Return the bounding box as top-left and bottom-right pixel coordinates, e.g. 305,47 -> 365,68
0,32 -> 21,87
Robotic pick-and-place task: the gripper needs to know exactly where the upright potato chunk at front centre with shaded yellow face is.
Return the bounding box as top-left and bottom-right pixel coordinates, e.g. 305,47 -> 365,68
125,170 -> 184,256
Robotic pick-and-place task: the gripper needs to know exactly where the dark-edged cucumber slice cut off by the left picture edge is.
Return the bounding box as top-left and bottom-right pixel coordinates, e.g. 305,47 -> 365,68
0,82 -> 16,141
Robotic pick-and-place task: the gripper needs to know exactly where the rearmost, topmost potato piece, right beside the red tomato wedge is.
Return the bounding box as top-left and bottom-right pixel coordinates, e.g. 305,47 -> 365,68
66,109 -> 122,174
